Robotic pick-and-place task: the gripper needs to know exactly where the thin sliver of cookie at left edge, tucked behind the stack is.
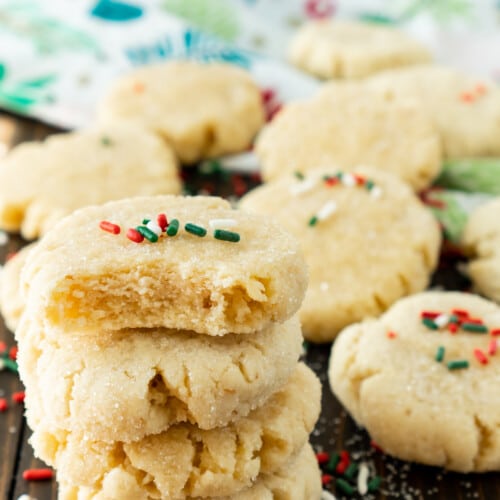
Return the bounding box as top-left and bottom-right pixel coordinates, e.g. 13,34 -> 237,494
0,243 -> 36,332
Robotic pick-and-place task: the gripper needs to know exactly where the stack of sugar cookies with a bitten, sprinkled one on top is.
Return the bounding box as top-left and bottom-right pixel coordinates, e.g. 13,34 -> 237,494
16,196 -> 321,500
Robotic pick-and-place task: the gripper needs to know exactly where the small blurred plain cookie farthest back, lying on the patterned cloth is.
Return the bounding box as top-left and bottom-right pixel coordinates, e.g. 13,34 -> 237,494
288,20 -> 431,78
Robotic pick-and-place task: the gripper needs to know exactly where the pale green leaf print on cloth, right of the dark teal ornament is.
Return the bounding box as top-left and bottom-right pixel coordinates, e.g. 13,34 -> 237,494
162,0 -> 240,42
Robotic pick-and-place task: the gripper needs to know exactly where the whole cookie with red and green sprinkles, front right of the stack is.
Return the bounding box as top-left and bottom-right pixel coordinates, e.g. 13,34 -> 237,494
329,292 -> 500,472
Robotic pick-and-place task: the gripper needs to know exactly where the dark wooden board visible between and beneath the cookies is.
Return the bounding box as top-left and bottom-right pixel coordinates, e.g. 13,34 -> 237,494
0,114 -> 500,500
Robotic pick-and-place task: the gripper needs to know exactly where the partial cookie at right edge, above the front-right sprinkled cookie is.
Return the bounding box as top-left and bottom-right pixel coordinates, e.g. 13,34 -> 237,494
462,198 -> 500,302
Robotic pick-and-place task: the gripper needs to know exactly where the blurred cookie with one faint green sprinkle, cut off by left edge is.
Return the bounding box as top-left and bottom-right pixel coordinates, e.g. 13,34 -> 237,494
0,124 -> 181,239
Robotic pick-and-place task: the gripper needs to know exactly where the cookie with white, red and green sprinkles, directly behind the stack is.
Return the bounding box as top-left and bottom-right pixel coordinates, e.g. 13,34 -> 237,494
240,167 -> 441,342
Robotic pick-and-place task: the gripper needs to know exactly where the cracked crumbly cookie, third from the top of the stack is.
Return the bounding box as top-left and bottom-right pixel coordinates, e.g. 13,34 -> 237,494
28,364 -> 321,498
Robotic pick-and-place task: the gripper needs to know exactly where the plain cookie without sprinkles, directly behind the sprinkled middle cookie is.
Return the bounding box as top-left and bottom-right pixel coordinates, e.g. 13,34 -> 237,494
256,82 -> 441,190
